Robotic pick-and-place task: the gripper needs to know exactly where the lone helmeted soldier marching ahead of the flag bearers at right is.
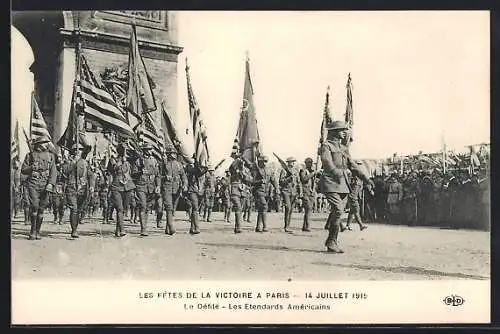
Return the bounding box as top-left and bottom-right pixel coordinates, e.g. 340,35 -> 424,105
319,121 -> 373,253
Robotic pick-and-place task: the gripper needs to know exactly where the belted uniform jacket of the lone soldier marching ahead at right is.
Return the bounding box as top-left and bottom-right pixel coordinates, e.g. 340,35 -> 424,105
320,139 -> 369,194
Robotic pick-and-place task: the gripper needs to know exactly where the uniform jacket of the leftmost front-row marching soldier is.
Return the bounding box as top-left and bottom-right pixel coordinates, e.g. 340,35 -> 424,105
21,151 -> 57,190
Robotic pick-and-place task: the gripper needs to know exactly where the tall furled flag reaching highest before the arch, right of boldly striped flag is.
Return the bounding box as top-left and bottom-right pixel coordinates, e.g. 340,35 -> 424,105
126,25 -> 156,128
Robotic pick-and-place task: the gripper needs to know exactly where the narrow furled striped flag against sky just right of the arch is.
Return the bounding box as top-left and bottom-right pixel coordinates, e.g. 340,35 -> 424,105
186,59 -> 210,166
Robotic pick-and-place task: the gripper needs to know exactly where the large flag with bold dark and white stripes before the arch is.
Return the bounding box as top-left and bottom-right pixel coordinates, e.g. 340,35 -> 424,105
77,55 -> 135,139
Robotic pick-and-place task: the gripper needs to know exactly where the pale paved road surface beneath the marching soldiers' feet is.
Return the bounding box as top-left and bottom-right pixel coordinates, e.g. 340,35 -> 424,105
12,212 -> 490,280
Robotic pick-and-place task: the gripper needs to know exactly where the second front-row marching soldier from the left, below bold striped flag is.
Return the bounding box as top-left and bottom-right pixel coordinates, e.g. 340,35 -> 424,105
61,145 -> 95,238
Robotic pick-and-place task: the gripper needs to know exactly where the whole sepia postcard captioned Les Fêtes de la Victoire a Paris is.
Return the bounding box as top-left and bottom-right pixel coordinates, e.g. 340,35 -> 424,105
10,9 -> 491,324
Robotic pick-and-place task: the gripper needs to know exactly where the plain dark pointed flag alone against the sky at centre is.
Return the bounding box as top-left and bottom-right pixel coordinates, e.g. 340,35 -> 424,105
231,54 -> 262,161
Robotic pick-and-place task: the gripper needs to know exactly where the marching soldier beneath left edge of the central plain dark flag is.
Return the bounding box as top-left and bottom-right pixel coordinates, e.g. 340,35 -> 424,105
229,153 -> 252,233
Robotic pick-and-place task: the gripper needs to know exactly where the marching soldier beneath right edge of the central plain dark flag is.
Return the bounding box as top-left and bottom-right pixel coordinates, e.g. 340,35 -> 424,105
253,155 -> 277,232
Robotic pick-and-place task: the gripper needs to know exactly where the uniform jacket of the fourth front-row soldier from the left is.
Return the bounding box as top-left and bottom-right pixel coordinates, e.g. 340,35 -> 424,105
132,156 -> 161,193
